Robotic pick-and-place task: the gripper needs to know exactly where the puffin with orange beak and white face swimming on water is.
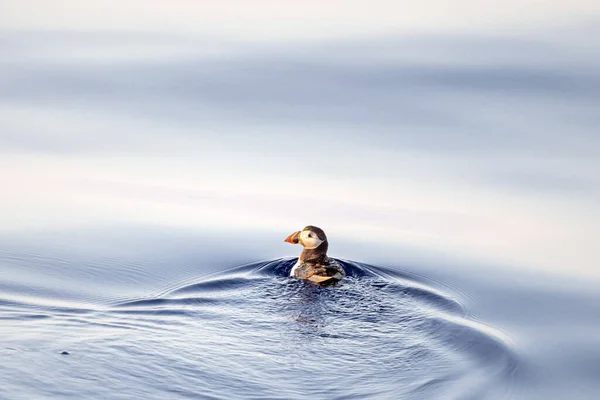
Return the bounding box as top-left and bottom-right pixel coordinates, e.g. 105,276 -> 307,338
284,225 -> 346,286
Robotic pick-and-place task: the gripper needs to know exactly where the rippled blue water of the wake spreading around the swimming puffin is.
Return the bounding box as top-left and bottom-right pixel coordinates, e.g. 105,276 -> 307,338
0,242 -> 518,399
